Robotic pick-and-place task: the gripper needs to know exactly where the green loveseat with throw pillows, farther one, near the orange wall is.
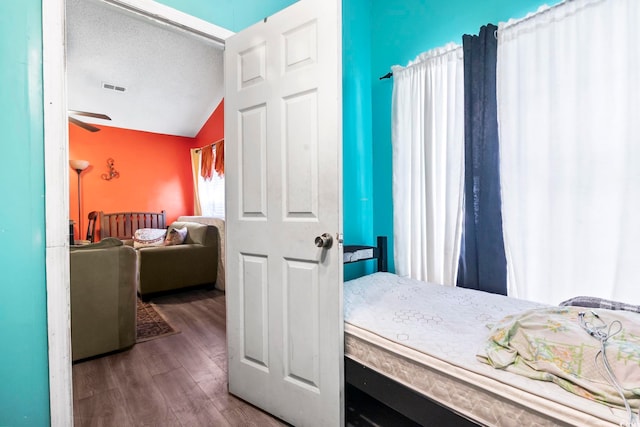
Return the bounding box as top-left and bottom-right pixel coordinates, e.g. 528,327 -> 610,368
137,221 -> 218,299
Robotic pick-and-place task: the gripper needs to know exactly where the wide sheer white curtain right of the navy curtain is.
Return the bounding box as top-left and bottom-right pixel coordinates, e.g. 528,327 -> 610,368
498,0 -> 640,304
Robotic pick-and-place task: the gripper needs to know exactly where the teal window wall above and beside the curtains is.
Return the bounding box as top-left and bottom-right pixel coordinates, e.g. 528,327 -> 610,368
371,0 -> 544,271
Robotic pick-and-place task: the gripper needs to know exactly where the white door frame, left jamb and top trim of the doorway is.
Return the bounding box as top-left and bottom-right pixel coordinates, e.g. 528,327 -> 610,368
42,0 -> 233,427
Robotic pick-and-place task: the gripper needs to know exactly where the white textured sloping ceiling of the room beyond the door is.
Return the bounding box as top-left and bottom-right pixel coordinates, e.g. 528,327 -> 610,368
66,0 -> 224,137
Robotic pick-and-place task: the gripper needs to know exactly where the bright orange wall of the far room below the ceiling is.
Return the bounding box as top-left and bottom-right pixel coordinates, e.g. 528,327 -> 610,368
69,101 -> 224,239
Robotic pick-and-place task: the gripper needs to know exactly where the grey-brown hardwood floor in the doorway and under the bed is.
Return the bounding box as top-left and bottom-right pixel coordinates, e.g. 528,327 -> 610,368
73,289 -> 416,427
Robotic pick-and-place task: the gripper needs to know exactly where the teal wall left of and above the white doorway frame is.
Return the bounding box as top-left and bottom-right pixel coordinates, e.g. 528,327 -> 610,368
0,0 -> 294,426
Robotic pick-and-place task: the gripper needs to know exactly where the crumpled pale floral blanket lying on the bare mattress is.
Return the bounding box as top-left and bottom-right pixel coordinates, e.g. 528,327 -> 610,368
477,307 -> 640,409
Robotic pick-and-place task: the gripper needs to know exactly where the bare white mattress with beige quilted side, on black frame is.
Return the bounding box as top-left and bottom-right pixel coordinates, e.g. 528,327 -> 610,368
344,273 -> 626,426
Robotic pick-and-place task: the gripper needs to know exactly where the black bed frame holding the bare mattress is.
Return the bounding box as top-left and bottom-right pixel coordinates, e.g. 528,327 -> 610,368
344,236 -> 478,427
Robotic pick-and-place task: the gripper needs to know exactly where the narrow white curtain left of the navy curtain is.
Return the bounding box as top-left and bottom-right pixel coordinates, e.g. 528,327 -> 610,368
392,44 -> 464,285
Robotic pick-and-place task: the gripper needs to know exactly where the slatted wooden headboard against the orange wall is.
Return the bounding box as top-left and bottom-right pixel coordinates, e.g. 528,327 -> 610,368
100,211 -> 167,240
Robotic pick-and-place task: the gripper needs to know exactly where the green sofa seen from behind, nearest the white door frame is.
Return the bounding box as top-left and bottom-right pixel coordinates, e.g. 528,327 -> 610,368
69,238 -> 137,361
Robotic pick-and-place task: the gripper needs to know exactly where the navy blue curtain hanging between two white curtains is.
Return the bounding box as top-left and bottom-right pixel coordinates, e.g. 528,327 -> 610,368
458,24 -> 507,295
